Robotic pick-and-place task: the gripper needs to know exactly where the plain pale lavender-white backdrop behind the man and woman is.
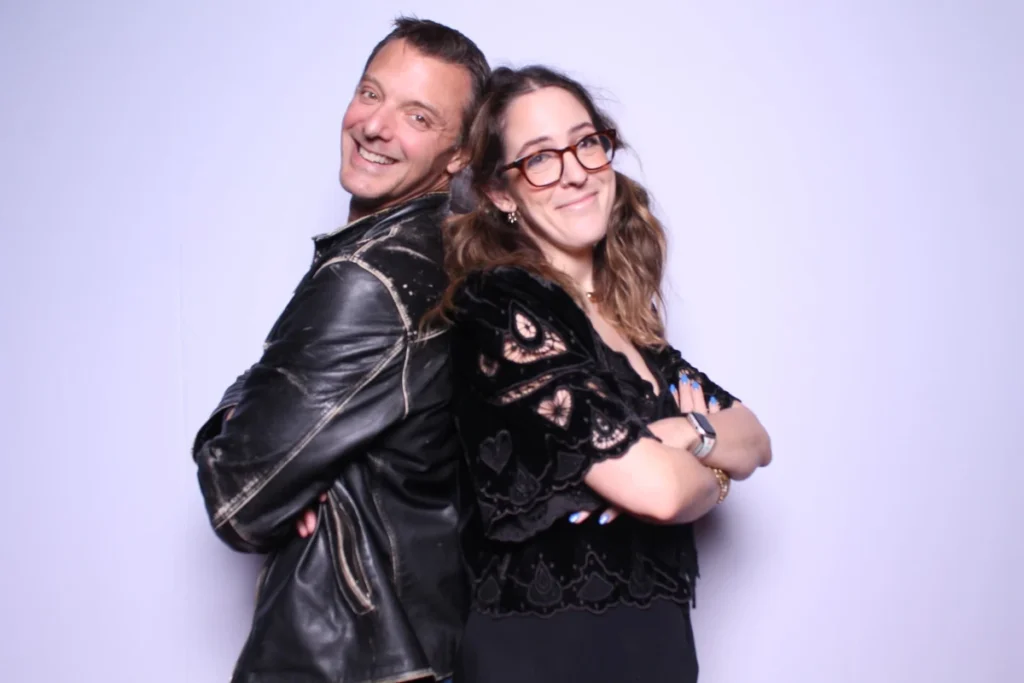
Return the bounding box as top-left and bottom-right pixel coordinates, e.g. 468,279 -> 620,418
0,0 -> 1024,683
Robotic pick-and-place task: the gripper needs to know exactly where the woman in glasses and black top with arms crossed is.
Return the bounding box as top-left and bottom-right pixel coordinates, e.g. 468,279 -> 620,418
428,67 -> 770,683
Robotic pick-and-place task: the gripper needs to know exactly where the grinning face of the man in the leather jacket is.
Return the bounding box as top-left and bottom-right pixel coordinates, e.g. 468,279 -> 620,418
339,40 -> 472,219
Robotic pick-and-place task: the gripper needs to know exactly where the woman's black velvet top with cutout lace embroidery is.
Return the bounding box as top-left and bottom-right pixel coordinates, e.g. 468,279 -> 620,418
453,267 -> 735,615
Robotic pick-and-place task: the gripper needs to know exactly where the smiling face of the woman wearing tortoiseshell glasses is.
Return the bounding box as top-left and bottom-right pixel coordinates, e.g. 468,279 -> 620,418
492,87 -> 615,261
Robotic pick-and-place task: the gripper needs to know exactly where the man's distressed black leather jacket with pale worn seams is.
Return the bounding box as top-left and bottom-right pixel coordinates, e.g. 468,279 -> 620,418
194,195 -> 469,683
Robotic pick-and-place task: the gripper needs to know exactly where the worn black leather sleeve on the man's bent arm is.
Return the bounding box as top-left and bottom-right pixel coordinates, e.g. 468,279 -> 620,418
193,260 -> 408,552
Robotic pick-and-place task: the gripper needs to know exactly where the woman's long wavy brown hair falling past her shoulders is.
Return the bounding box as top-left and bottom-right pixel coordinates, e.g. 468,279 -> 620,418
427,67 -> 666,347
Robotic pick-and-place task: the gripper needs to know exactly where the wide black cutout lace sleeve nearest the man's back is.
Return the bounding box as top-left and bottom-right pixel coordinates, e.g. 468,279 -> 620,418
452,268 -> 650,541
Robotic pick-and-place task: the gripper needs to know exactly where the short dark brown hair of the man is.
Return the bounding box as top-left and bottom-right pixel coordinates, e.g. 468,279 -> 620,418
362,16 -> 490,145
